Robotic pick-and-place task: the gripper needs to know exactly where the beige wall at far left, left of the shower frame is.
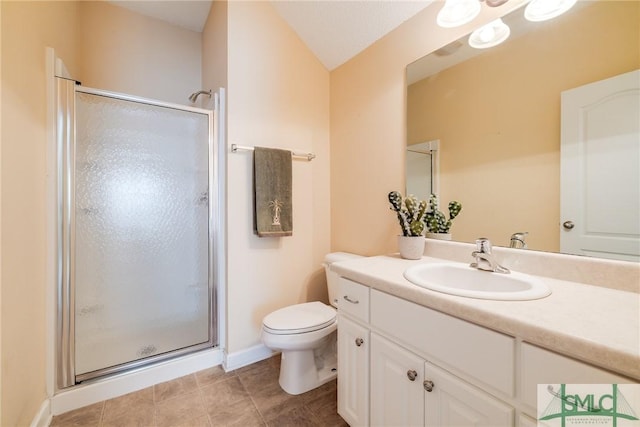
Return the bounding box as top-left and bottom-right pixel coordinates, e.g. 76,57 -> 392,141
0,1 -> 78,426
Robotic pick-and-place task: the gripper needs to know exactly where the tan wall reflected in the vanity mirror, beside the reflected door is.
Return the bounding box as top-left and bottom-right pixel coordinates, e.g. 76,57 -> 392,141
407,1 -> 640,260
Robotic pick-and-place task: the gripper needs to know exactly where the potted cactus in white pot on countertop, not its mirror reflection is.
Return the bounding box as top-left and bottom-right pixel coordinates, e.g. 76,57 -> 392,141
389,191 -> 427,259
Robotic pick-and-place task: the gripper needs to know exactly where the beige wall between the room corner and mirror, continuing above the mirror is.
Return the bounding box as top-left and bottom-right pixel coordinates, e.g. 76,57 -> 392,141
330,1 -> 522,255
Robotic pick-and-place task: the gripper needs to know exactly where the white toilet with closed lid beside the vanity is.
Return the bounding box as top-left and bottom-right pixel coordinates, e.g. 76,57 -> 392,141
262,252 -> 360,394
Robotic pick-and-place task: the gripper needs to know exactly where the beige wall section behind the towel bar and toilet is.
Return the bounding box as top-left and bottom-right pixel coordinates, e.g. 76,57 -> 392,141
220,1 -> 330,353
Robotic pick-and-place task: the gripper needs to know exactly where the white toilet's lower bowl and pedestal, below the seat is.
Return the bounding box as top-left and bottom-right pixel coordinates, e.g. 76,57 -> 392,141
279,332 -> 338,395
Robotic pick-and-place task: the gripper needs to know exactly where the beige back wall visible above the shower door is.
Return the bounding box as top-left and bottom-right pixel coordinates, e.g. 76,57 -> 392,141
74,1 -> 202,105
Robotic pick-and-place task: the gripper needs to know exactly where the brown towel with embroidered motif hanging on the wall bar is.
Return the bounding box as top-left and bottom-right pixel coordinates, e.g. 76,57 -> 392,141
253,147 -> 293,237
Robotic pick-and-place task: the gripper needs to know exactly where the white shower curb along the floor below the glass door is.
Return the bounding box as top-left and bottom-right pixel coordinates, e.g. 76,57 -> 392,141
48,348 -> 223,416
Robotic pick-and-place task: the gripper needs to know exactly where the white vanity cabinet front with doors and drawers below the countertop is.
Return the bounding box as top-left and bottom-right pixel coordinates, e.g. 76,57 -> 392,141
338,277 -> 637,427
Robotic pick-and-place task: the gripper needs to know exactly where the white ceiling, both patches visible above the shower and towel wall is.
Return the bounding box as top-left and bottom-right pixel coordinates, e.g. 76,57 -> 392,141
110,0 -> 434,70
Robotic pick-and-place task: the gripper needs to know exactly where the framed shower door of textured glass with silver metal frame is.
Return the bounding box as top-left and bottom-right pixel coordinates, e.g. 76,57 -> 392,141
56,78 -> 218,388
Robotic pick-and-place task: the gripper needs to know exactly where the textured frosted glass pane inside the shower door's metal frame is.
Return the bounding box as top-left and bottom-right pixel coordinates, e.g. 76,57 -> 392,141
75,93 -> 210,374
